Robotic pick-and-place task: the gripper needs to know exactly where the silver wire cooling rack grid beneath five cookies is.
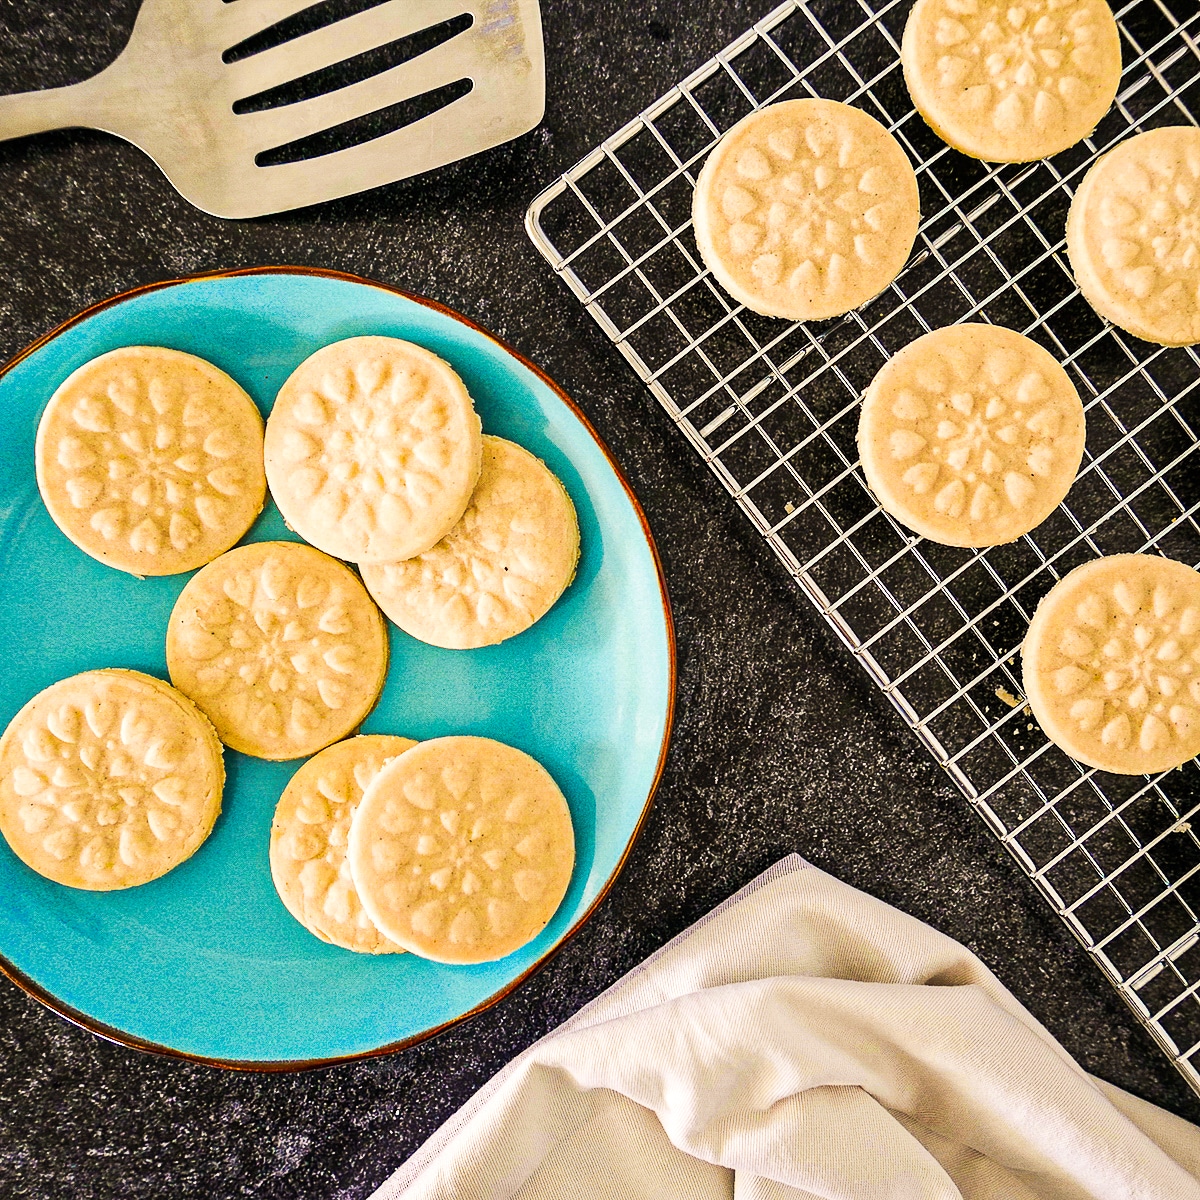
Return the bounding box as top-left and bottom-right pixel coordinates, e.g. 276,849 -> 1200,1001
527,0 -> 1200,1092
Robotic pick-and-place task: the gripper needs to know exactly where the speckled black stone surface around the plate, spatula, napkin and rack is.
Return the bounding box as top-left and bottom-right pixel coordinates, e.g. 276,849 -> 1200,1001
0,0 -> 1200,1200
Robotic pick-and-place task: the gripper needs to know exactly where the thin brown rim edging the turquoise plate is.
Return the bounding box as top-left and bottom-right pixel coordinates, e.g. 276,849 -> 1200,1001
0,265 -> 678,1073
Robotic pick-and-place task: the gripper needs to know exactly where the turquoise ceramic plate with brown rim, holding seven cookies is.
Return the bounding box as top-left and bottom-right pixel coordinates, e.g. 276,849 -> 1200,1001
0,268 -> 674,1069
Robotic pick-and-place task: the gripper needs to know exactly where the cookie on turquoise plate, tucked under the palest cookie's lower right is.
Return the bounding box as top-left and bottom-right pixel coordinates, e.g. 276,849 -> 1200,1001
362,437 -> 580,650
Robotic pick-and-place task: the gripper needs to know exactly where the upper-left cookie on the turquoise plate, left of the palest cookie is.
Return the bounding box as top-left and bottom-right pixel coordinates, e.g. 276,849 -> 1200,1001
36,346 -> 266,575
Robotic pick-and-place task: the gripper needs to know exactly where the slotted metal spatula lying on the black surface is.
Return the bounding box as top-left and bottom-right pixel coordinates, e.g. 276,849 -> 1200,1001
0,0 -> 546,217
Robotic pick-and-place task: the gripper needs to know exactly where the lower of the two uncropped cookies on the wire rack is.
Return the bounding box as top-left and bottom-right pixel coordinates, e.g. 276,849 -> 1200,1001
858,324 -> 1085,546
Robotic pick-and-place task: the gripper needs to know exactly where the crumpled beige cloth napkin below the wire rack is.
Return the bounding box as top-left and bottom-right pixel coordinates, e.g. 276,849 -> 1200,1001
374,856 -> 1200,1200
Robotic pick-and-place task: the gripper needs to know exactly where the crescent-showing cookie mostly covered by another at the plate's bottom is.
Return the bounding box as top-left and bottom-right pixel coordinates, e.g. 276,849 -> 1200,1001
270,733 -> 416,954
